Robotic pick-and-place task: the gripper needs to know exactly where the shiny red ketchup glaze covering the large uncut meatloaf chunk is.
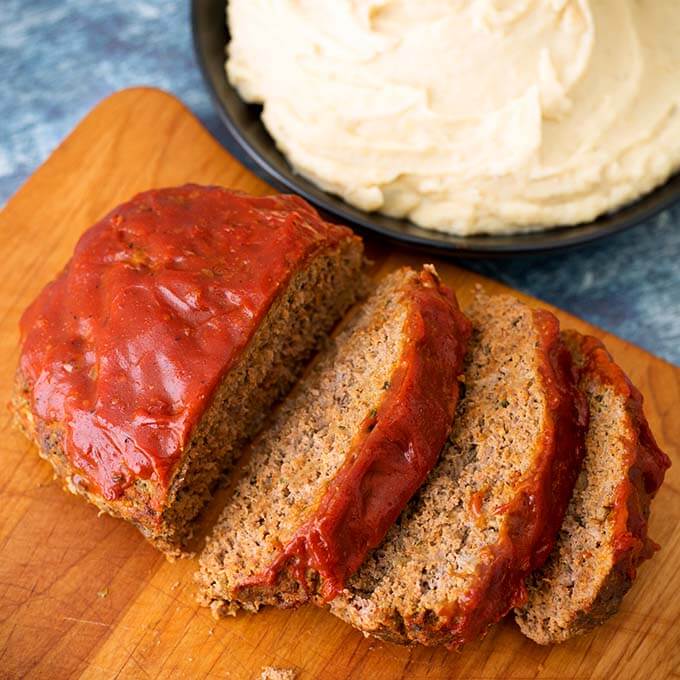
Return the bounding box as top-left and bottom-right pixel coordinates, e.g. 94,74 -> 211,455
20,185 -> 356,506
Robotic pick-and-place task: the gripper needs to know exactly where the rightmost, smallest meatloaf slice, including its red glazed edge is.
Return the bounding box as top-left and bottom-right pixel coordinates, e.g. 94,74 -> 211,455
516,331 -> 670,644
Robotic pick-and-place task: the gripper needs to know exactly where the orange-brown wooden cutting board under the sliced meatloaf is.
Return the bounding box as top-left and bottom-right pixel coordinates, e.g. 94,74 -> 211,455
0,89 -> 680,680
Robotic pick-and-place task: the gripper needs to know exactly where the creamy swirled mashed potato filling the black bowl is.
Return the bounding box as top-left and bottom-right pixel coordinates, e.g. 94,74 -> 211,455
227,0 -> 680,235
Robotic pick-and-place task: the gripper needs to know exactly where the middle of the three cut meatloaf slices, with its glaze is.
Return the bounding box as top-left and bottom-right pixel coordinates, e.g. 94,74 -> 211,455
330,293 -> 586,648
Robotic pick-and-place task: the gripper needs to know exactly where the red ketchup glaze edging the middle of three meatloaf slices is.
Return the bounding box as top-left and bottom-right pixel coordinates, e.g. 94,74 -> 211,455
418,309 -> 588,648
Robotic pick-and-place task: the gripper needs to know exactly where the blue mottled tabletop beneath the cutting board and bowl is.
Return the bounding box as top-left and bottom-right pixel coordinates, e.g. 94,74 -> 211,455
0,0 -> 680,364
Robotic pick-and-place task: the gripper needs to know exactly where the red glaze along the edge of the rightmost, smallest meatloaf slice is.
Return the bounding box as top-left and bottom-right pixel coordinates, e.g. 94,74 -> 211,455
570,331 -> 671,580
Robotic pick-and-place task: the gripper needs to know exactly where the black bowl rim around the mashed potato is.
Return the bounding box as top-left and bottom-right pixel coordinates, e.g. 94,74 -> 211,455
191,0 -> 680,258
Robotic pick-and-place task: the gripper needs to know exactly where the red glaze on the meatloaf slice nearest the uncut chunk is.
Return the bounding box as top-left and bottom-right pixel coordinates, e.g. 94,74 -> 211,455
240,272 -> 471,602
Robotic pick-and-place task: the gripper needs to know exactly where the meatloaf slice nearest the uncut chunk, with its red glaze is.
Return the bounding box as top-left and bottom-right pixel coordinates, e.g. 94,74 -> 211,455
197,267 -> 470,616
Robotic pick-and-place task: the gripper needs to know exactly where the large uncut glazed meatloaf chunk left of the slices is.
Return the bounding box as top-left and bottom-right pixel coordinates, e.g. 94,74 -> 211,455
14,185 -> 365,556
